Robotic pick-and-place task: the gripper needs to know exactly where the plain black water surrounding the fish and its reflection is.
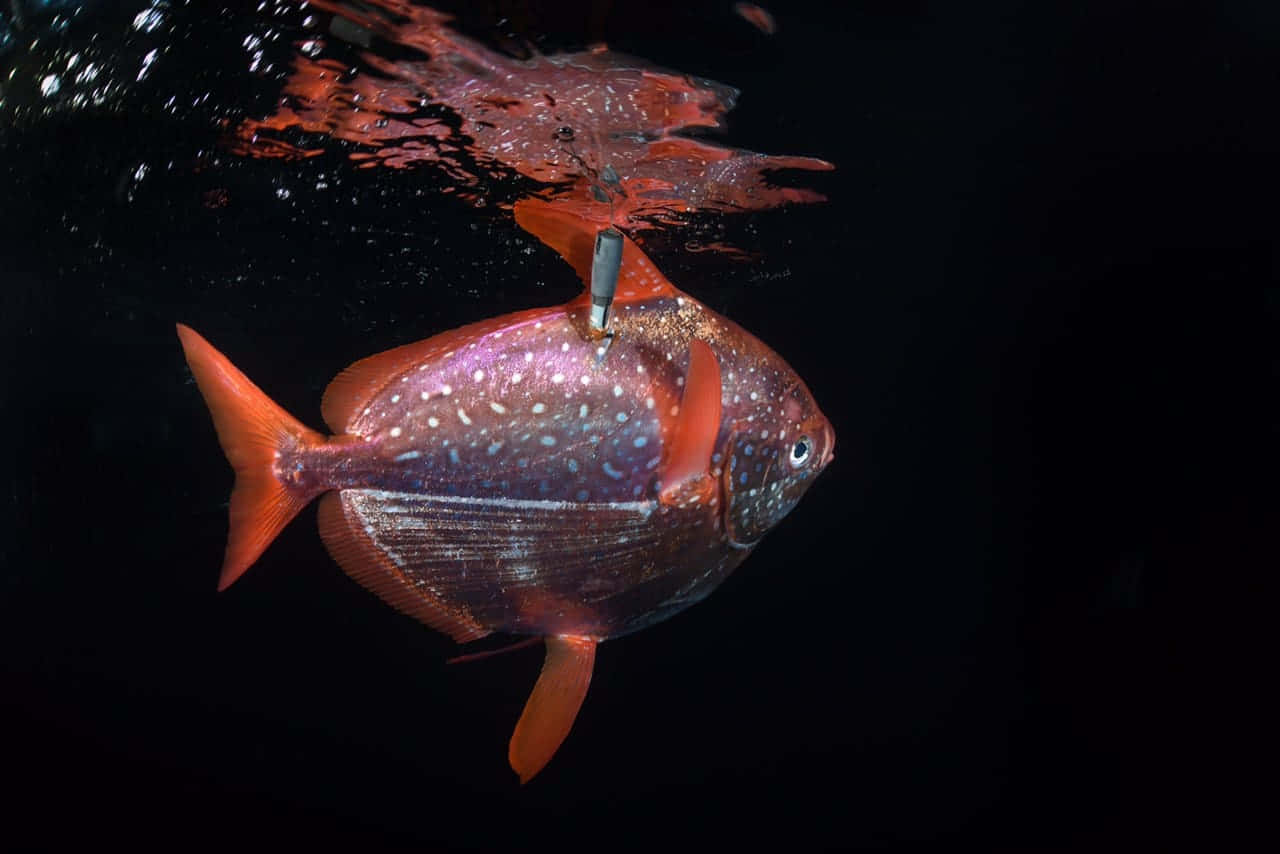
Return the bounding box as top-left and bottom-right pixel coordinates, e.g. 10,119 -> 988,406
0,0 -> 1280,850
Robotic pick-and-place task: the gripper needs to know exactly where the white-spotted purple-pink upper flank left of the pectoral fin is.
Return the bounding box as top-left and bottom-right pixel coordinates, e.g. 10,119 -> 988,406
349,307 -> 680,502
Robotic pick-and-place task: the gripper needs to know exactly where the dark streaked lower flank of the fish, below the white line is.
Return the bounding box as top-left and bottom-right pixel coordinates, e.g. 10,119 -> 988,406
342,489 -> 745,636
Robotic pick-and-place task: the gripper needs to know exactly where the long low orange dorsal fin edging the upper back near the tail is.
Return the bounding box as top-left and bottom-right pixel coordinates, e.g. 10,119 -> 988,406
320,307 -> 563,433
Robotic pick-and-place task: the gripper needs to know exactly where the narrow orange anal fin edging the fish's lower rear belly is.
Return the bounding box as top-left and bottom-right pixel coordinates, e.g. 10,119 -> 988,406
319,492 -> 489,643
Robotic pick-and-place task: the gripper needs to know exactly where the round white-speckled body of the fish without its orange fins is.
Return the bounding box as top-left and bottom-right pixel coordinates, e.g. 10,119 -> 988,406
275,292 -> 831,639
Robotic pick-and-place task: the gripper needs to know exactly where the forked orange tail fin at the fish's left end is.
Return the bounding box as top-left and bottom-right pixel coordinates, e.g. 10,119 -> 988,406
178,324 -> 324,590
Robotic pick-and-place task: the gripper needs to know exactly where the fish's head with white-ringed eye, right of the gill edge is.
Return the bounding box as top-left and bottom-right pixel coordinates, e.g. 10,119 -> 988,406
721,379 -> 836,547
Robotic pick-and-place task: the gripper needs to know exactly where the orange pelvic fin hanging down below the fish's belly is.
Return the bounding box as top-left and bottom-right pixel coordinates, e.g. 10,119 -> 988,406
507,635 -> 596,785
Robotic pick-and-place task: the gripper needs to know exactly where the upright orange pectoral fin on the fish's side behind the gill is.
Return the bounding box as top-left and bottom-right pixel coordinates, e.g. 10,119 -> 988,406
659,338 -> 721,504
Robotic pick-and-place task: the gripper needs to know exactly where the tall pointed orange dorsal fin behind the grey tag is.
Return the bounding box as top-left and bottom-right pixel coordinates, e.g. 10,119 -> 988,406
516,198 -> 681,302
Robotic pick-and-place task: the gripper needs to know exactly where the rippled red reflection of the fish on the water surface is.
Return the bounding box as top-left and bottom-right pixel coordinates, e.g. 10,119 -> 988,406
228,0 -> 832,239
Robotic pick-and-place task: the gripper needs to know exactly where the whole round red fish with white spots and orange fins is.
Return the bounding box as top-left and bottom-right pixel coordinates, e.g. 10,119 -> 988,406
179,206 -> 835,780
